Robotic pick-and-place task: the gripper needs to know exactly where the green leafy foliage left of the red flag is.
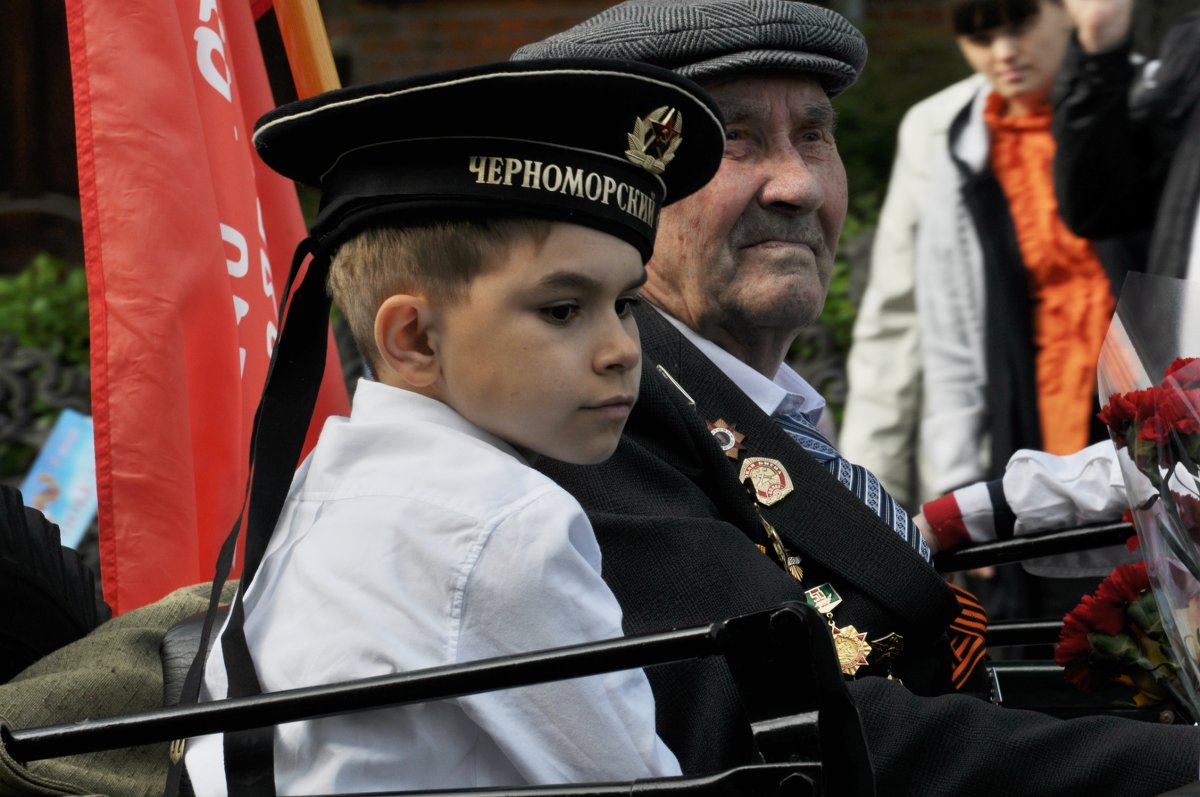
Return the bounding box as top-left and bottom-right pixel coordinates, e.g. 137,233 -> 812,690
0,254 -> 89,365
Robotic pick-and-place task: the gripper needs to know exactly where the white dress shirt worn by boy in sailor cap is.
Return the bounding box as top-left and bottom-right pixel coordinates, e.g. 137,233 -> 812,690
187,382 -> 679,796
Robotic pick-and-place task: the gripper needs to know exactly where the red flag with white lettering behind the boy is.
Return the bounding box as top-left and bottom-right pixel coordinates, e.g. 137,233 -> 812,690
66,0 -> 348,612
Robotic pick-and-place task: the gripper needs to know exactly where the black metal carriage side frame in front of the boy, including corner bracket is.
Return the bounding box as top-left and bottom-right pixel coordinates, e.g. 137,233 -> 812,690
0,604 -> 875,797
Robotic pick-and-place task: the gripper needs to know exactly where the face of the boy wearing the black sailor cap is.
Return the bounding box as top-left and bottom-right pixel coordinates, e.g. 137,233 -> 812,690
434,223 -> 646,465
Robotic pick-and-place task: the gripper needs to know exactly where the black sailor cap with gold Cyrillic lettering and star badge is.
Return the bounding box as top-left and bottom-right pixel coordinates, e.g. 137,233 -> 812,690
254,59 -> 725,259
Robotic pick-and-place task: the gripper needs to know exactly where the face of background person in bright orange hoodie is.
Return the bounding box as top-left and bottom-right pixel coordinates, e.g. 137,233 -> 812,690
958,0 -> 1072,113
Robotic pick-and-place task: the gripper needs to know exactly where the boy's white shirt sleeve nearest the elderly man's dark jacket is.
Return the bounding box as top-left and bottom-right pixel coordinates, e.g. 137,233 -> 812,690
454,490 -> 680,784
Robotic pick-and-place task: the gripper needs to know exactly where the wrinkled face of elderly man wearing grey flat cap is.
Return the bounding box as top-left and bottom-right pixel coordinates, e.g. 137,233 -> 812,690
644,76 -> 846,360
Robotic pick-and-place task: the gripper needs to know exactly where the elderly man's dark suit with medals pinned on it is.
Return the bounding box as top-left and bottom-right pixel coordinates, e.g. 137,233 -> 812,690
539,306 -> 1200,797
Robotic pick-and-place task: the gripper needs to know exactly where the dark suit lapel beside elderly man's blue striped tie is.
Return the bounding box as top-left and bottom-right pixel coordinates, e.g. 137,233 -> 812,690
637,306 -> 958,628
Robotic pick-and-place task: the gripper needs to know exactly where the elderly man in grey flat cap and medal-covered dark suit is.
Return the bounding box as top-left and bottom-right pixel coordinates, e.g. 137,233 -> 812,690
514,0 -> 1200,795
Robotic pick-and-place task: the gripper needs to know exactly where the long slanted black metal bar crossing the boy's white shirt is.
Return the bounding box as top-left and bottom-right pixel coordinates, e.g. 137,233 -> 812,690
4,621 -> 715,762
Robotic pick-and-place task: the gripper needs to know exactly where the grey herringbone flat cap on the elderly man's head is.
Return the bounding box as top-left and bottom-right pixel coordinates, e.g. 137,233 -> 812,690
512,0 -> 866,97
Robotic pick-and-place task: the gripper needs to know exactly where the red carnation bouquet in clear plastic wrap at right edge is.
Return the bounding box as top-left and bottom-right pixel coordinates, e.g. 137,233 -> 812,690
1075,274 -> 1200,718
